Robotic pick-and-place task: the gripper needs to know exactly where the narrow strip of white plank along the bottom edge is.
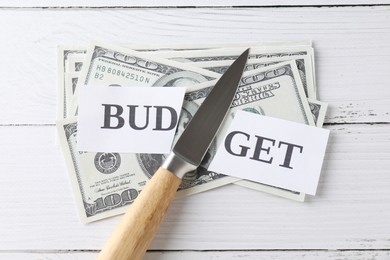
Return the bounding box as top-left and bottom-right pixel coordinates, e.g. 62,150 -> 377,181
0,250 -> 390,260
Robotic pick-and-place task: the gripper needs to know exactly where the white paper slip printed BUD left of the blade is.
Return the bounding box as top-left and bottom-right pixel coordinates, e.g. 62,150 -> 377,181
77,86 -> 185,154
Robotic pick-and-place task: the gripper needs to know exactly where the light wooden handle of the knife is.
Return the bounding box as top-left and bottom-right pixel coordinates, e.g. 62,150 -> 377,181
98,167 -> 181,260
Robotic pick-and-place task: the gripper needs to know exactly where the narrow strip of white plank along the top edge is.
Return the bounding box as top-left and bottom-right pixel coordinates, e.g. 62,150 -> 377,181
0,0 -> 390,8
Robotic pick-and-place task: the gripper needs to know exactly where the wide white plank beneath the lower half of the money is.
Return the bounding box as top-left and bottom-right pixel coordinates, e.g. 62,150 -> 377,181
0,124 -> 390,250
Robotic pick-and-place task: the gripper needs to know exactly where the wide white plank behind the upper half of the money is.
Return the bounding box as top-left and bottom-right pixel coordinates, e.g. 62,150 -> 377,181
0,7 -> 390,125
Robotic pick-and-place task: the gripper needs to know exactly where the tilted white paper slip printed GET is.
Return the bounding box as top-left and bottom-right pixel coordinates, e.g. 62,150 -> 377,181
209,111 -> 329,195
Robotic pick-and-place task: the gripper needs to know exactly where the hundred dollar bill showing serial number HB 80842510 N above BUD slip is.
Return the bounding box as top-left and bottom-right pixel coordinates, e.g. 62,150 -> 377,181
72,44 -> 220,114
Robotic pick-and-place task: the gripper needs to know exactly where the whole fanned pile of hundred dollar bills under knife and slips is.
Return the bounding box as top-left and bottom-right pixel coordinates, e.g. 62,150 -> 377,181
57,41 -> 327,222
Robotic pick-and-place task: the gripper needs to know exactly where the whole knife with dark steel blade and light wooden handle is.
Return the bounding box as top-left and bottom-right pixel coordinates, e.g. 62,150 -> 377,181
98,49 -> 249,260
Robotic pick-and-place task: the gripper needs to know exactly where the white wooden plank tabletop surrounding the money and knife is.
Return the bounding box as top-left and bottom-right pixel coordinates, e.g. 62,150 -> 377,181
0,0 -> 390,260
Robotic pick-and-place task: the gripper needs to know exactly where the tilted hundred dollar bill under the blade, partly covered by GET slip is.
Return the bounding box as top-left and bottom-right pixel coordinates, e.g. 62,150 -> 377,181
143,61 -> 314,200
